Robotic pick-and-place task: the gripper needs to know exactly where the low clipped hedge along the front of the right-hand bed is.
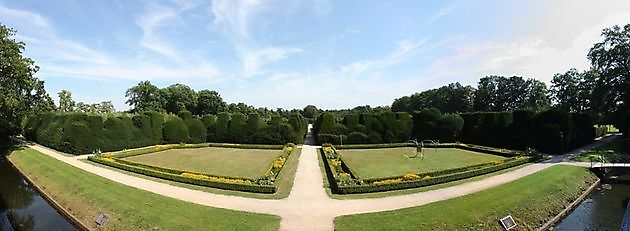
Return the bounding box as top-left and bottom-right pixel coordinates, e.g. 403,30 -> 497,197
335,158 -> 529,194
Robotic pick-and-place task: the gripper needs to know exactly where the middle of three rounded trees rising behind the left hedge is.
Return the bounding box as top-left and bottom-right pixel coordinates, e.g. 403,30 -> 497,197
161,83 -> 197,114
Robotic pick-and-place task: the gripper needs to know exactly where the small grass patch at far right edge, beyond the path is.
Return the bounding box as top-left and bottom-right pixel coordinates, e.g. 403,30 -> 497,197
573,138 -> 630,162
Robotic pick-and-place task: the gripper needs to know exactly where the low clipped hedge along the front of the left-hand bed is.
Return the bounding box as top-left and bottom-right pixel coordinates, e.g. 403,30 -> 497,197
88,156 -> 276,194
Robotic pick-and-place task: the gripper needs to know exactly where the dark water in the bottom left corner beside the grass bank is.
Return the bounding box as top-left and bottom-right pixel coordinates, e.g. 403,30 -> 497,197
0,142 -> 75,231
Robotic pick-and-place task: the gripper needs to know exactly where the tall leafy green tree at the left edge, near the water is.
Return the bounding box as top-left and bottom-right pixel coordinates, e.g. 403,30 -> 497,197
0,24 -> 54,136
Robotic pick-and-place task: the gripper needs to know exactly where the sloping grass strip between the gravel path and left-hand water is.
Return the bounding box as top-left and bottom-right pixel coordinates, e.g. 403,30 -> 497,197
9,149 -> 280,230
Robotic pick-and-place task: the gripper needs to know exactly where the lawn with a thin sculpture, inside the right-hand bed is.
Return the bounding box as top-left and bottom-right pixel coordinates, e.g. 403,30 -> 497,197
338,148 -> 505,179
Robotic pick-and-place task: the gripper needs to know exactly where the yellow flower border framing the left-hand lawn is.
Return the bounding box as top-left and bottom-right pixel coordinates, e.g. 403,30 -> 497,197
88,144 -> 296,194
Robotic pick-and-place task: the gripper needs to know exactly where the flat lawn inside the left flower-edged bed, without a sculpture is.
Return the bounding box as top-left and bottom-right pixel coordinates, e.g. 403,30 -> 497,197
125,147 -> 282,178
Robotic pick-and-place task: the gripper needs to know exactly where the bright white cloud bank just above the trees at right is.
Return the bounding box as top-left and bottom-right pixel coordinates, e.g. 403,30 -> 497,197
420,12 -> 630,83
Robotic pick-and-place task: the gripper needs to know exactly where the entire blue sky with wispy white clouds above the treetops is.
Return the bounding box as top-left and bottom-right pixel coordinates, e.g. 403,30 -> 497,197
0,0 -> 630,110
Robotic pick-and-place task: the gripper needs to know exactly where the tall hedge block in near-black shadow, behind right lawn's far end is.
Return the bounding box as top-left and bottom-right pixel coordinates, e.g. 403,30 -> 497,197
460,109 -> 595,153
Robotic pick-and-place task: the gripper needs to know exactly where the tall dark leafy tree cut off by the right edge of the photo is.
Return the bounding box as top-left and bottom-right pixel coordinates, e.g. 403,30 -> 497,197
588,24 -> 630,132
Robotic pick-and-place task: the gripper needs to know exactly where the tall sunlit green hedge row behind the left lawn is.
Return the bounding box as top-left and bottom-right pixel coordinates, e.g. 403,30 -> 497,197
24,111 -> 307,154
